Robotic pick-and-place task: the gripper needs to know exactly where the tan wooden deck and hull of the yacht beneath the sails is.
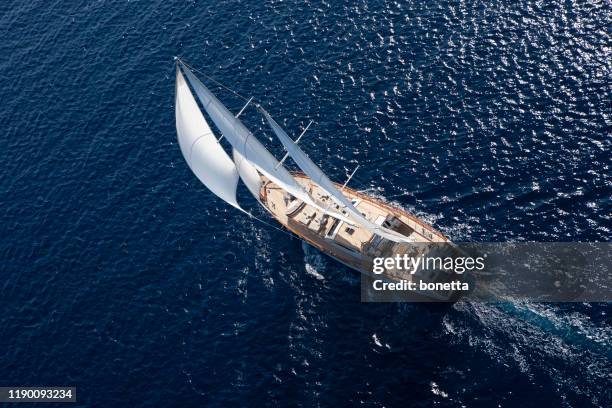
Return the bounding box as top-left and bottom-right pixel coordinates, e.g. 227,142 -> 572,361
260,173 -> 464,296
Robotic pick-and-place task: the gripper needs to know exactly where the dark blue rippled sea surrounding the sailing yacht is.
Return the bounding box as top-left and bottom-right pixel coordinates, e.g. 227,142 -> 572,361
0,0 -> 612,407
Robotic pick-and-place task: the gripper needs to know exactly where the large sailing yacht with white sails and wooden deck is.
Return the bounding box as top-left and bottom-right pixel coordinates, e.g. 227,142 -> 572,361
175,58 -> 470,301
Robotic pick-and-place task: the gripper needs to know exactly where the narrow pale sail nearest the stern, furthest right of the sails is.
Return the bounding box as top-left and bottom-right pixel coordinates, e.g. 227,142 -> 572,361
260,108 -> 409,242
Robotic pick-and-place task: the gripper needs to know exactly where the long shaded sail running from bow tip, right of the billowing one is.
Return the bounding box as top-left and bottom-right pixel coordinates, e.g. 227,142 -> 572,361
181,63 -> 353,224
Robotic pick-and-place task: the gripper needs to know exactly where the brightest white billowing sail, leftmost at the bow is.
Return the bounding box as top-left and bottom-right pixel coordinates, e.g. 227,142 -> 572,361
175,67 -> 244,211
